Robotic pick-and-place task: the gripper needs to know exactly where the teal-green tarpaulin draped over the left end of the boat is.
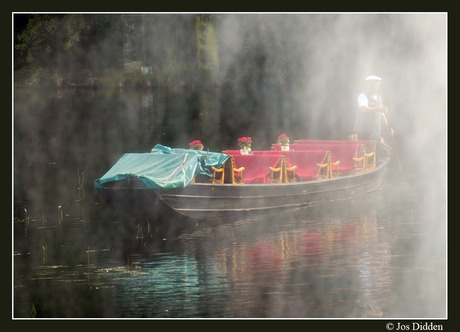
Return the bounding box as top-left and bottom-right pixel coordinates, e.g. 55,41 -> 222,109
94,144 -> 229,190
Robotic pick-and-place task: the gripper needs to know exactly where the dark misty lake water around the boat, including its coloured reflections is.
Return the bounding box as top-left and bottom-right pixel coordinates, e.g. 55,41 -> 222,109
12,89 -> 447,320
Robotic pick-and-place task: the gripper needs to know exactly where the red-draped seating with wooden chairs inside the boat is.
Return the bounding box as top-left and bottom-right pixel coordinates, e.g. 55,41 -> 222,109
217,140 -> 375,184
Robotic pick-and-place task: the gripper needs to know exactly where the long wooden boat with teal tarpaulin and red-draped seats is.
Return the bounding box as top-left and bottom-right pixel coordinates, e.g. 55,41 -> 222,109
95,140 -> 390,225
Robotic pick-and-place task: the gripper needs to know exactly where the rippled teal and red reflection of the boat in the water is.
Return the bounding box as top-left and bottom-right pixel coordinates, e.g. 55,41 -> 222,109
100,196 -> 398,317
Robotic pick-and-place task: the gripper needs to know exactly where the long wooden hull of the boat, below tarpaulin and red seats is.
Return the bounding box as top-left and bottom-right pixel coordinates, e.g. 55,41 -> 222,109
101,159 -> 389,224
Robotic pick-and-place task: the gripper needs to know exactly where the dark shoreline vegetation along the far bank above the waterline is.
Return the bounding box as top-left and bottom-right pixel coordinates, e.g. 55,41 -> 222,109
13,14 -> 298,88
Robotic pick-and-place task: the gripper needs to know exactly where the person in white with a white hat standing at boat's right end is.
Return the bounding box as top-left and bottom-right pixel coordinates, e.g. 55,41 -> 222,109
353,76 -> 393,158
